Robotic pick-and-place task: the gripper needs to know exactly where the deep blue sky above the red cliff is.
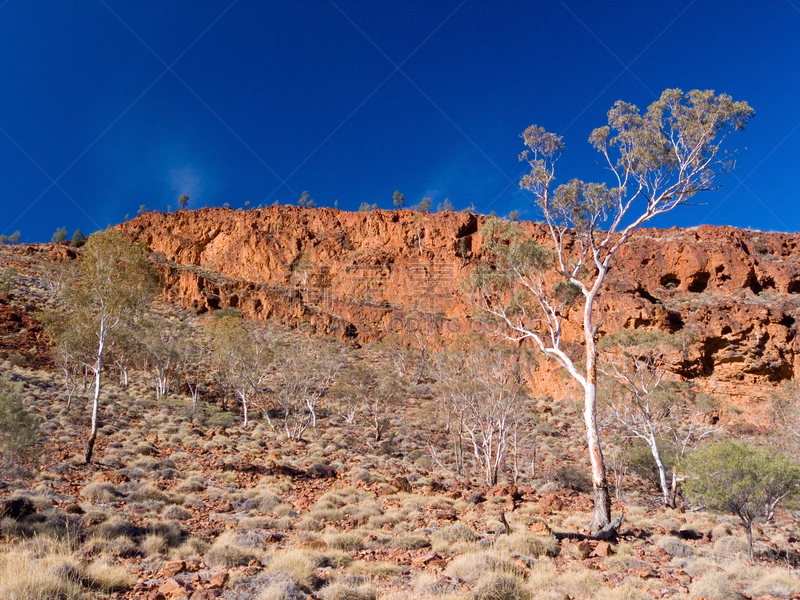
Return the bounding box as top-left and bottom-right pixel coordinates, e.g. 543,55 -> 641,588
0,0 -> 800,241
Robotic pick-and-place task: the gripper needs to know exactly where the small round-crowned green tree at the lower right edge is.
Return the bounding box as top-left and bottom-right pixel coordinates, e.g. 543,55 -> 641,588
682,440 -> 800,560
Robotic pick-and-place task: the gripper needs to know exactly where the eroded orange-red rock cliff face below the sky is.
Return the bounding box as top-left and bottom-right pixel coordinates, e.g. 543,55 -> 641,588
120,206 -> 800,406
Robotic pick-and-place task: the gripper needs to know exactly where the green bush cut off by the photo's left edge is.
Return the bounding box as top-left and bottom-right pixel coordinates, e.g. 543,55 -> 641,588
0,379 -> 41,472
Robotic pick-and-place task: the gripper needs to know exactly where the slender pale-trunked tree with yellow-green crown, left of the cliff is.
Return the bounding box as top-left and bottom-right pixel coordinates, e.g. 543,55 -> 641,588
46,229 -> 159,464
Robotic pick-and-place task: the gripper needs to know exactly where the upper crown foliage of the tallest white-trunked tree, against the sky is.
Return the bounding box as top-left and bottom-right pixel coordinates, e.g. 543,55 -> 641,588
520,89 -> 755,235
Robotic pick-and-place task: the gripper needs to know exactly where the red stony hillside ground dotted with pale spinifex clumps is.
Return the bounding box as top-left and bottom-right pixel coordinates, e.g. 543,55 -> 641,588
0,232 -> 800,600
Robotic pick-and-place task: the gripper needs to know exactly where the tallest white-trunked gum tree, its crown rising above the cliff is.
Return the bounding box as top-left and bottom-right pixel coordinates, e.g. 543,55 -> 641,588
475,89 -> 754,529
